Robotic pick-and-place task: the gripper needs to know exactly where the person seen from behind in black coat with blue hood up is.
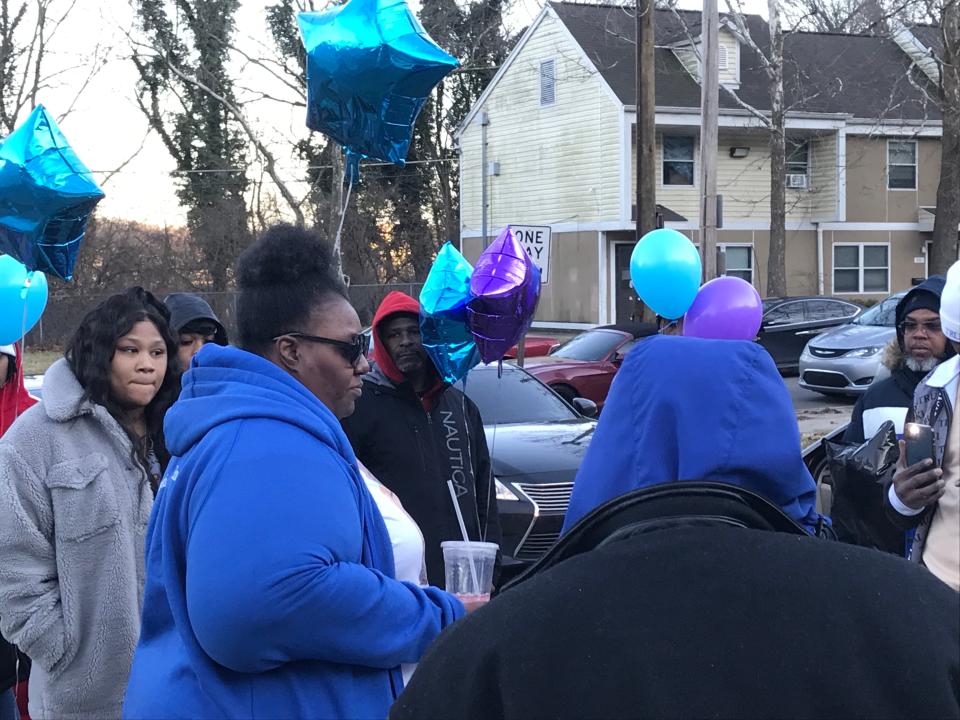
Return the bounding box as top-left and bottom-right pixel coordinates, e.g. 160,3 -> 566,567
390,336 -> 960,720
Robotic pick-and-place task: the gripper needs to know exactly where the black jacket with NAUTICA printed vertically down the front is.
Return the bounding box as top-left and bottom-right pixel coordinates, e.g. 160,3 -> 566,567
343,368 -> 500,587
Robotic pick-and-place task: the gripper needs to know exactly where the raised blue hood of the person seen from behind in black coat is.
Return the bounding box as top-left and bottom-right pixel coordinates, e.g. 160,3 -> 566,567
563,336 -> 820,533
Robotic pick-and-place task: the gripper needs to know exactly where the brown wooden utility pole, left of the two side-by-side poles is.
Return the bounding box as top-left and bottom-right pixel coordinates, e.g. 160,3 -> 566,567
636,0 -> 657,240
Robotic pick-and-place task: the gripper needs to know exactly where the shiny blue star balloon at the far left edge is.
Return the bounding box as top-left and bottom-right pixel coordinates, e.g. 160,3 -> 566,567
0,105 -> 103,280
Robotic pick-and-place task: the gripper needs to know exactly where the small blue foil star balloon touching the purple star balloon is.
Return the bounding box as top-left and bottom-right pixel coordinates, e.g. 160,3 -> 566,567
420,242 -> 480,385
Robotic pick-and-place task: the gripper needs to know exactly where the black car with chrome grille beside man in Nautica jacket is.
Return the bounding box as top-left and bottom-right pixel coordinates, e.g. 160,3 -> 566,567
466,363 -> 596,564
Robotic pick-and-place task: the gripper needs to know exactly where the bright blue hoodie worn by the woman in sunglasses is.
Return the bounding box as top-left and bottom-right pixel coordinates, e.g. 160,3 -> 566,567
124,345 -> 463,720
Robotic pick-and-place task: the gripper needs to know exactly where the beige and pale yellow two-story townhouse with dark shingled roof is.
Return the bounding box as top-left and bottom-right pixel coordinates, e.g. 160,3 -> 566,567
457,2 -> 941,329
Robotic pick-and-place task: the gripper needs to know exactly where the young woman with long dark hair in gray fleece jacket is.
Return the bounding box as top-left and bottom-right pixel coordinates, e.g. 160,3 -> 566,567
0,288 -> 179,720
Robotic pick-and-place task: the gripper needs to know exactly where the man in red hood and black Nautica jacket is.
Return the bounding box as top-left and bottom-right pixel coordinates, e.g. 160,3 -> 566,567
342,292 -> 500,587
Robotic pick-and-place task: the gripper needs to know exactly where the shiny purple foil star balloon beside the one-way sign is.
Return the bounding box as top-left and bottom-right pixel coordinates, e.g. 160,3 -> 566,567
467,227 -> 540,363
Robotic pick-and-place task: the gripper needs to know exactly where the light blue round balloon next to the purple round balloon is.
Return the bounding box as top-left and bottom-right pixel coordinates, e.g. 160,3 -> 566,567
630,228 -> 703,320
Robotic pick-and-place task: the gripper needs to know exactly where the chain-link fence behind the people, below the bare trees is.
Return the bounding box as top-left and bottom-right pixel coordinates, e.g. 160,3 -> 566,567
26,283 -> 423,349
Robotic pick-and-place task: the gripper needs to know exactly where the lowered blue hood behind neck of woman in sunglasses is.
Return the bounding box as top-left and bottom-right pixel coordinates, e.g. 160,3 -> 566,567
163,344 -> 356,466
